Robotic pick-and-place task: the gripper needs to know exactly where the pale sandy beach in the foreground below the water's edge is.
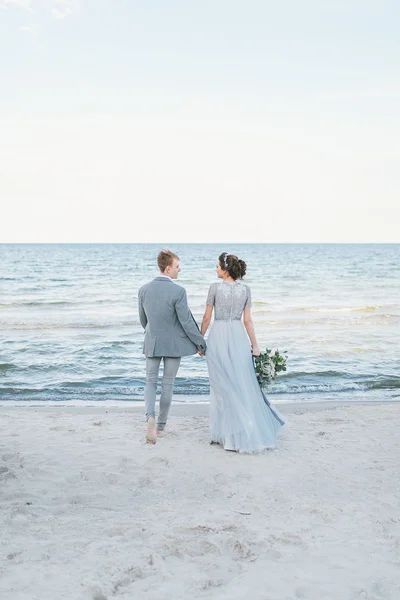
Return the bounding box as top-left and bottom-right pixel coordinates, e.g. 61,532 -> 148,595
0,404 -> 400,600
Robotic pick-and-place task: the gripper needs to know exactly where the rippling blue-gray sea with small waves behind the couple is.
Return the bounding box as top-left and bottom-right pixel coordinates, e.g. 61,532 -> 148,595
0,241 -> 400,406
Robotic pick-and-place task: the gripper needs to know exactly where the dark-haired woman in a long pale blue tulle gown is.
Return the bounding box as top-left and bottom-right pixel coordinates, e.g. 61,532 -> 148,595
201,253 -> 284,452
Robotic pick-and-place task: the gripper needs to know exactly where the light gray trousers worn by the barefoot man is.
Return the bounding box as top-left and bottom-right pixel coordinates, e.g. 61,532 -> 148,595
144,356 -> 181,431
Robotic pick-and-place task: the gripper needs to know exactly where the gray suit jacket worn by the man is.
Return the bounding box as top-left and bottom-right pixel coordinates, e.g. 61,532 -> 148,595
139,277 -> 206,357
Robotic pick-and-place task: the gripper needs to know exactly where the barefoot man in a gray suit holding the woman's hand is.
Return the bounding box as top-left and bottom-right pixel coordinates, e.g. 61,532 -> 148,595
139,250 -> 206,444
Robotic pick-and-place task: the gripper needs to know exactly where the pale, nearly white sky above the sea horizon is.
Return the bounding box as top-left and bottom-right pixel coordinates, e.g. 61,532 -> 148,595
0,0 -> 400,243
